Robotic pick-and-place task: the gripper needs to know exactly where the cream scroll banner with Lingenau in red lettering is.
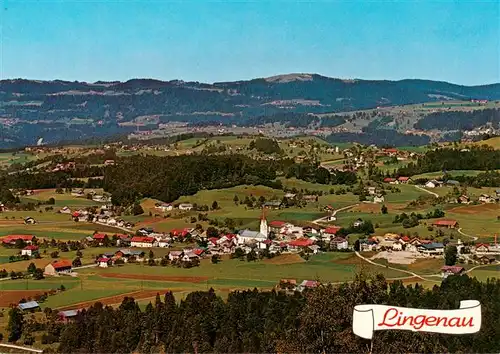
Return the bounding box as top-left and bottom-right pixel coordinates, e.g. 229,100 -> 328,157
352,300 -> 481,339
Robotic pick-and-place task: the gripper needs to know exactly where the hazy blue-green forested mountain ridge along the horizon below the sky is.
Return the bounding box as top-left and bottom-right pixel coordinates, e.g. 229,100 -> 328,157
0,74 -> 500,147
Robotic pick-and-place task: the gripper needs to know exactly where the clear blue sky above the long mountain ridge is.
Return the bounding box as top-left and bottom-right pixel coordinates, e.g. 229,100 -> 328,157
0,0 -> 500,85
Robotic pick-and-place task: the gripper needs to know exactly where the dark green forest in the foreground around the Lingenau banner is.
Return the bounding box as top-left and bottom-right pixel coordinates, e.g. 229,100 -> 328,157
11,273 -> 500,353
